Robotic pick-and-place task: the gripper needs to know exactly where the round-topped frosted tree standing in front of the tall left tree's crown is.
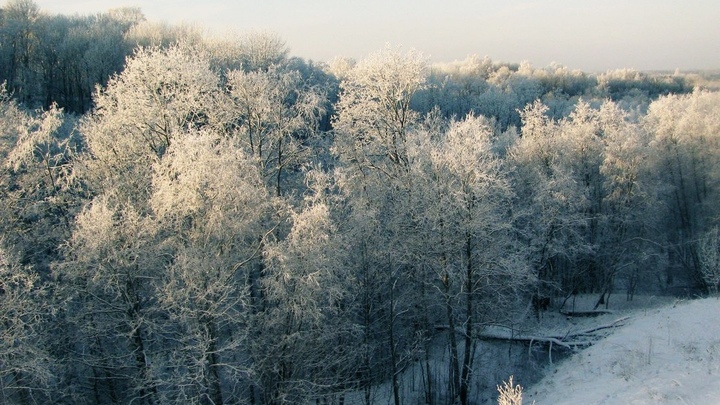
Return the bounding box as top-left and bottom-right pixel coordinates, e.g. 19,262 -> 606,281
150,131 -> 270,403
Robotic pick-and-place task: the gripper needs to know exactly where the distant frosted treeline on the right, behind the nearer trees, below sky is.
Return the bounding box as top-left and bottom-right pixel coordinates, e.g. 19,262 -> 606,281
415,56 -> 693,131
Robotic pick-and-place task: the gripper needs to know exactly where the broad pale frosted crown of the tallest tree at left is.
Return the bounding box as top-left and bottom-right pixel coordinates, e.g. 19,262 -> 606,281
80,43 -> 220,203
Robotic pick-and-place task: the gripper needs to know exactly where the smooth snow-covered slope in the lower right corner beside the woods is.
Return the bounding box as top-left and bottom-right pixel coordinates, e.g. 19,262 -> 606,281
523,298 -> 720,405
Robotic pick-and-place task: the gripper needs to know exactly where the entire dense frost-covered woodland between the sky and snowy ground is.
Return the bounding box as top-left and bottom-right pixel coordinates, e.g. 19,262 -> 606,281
0,0 -> 720,405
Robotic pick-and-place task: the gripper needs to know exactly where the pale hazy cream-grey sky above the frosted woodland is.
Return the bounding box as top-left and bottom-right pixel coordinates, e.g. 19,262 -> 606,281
35,0 -> 720,72
